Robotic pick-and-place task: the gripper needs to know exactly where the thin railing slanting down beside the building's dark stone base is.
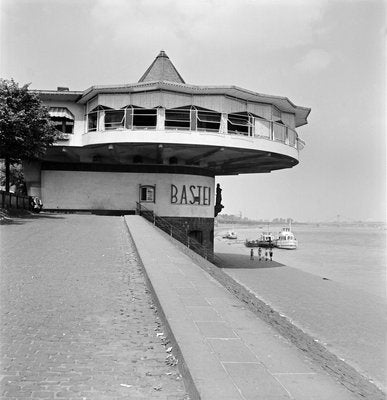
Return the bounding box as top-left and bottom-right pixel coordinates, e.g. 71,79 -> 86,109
137,202 -> 220,262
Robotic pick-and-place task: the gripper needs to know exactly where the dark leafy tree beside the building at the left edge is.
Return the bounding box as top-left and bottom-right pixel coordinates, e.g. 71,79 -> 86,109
0,79 -> 60,191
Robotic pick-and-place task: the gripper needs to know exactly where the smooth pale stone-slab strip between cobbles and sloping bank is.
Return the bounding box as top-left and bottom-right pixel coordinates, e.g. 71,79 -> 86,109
125,216 -> 358,400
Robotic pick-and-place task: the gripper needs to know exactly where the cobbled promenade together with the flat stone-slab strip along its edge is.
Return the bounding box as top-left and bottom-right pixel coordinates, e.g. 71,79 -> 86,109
1,214 -> 373,400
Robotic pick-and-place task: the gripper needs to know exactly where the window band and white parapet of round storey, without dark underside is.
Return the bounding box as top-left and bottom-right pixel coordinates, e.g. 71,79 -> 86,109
82,106 -> 301,150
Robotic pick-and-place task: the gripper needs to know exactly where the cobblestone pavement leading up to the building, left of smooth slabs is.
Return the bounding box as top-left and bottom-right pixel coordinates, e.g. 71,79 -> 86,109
0,214 -> 188,400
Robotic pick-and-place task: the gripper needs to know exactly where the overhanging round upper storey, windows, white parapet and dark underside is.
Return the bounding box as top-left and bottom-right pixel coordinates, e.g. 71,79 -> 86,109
47,107 -> 303,175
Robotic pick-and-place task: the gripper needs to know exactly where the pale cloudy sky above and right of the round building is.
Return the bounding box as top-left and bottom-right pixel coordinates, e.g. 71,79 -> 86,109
0,0 -> 386,221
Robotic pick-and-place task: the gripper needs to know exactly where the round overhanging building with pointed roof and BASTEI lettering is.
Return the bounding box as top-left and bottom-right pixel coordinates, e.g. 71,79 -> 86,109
24,51 -> 310,253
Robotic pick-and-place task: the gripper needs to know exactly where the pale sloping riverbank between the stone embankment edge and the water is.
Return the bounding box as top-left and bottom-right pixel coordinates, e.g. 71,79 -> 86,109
216,242 -> 387,391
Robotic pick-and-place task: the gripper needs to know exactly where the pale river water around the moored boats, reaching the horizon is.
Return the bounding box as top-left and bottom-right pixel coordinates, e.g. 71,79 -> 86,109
214,224 -> 387,300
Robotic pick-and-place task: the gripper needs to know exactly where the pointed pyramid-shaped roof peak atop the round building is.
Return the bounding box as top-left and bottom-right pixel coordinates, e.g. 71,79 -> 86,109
138,50 -> 185,83
